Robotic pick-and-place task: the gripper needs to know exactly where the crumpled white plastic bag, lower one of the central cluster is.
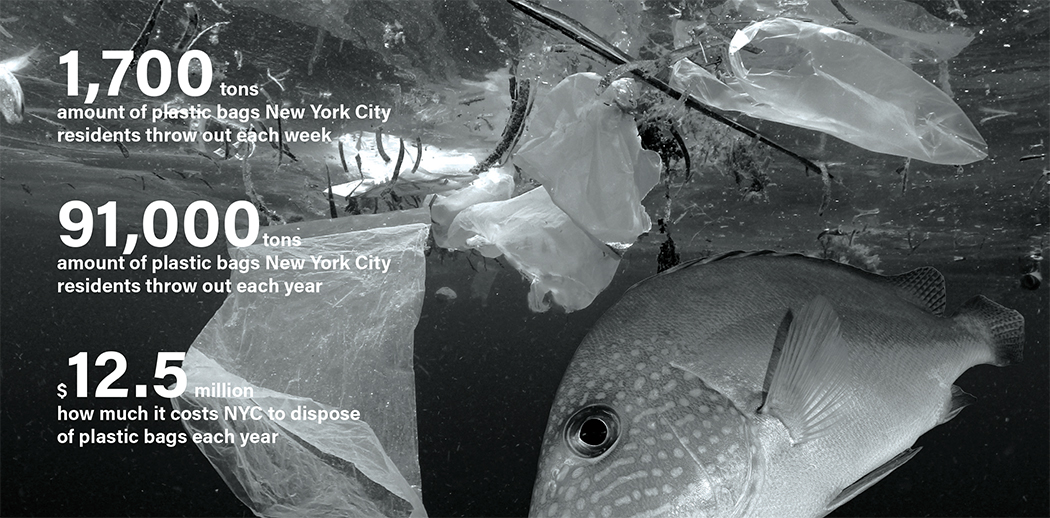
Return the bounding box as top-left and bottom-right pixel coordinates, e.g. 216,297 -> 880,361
448,188 -> 620,312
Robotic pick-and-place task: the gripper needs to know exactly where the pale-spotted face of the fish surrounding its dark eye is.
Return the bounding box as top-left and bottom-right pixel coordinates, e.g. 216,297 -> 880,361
533,338 -> 760,517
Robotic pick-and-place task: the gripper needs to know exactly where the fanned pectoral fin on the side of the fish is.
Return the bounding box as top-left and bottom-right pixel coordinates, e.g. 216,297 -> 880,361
760,295 -> 849,444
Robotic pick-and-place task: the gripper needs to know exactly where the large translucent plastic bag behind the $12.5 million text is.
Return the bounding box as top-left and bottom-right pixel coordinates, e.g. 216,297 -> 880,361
172,210 -> 429,517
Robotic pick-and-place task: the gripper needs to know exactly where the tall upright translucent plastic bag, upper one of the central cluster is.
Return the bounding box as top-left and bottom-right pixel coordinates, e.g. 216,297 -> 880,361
515,72 -> 662,244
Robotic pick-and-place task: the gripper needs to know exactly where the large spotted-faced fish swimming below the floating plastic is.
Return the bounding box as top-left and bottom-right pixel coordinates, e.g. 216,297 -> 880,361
529,251 -> 1024,518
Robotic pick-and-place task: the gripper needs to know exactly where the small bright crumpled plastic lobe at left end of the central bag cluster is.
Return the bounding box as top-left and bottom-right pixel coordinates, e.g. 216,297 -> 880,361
431,164 -> 515,249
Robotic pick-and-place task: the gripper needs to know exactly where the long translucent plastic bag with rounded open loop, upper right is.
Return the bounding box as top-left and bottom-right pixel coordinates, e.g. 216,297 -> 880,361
671,18 -> 988,165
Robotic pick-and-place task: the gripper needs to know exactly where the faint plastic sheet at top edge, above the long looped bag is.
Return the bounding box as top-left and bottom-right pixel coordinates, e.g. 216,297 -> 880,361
734,0 -> 973,63
